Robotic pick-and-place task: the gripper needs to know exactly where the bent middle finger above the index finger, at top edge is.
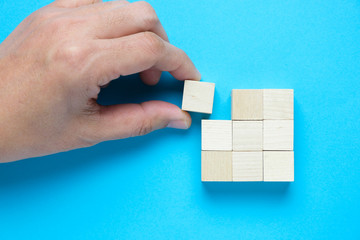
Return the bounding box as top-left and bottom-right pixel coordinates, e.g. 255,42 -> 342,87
94,2 -> 168,41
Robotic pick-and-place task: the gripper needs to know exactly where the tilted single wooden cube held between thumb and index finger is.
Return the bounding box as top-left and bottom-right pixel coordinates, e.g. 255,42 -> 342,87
181,80 -> 215,114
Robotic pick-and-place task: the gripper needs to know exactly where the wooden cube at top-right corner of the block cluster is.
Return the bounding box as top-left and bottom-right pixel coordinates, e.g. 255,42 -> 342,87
264,89 -> 294,120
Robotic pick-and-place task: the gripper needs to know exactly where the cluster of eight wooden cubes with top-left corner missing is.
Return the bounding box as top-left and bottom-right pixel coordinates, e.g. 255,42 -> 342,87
201,89 -> 294,182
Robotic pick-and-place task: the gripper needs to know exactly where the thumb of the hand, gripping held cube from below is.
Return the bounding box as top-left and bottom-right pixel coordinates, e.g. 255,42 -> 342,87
90,101 -> 191,142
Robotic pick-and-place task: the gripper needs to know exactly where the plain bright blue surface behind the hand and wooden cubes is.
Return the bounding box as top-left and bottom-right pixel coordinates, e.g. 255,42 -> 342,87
0,0 -> 360,240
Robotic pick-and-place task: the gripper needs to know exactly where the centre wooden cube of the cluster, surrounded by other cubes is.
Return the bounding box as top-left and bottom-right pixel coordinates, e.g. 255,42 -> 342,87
233,121 -> 263,151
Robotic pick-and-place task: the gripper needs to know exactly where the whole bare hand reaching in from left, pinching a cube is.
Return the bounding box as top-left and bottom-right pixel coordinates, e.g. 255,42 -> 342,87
0,0 -> 201,162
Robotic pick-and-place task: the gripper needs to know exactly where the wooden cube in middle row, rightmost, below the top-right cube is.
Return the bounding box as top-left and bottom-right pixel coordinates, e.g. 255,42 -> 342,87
263,120 -> 294,151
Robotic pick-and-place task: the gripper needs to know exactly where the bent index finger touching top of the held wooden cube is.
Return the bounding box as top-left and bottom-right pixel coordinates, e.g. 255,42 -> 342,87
90,32 -> 201,85
